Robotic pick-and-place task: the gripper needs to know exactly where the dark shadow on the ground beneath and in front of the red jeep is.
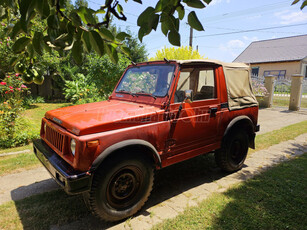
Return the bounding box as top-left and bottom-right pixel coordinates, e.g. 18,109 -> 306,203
11,154 -> 233,229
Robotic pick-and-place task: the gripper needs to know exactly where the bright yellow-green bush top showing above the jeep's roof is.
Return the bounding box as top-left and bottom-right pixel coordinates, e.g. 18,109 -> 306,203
150,46 -> 204,61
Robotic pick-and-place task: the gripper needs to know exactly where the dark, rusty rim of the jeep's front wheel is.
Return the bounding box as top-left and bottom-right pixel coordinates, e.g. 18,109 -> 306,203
106,166 -> 143,210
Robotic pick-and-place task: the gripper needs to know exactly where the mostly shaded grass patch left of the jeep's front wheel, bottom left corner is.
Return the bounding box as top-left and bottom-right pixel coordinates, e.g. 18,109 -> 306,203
0,190 -> 89,230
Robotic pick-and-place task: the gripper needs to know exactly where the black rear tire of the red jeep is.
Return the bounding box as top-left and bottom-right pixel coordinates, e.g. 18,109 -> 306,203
215,130 -> 248,172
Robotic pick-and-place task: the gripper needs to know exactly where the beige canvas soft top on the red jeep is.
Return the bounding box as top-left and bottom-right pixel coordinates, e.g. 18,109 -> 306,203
176,59 -> 258,110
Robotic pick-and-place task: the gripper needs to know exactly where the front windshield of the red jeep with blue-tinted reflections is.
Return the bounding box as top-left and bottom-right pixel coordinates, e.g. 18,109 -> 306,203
116,64 -> 175,97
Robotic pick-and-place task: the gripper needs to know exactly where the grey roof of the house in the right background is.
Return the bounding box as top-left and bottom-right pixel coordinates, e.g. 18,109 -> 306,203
234,35 -> 307,63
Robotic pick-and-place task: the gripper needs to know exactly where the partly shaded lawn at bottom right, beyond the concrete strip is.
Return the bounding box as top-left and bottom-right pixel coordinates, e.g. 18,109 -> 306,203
153,153 -> 307,230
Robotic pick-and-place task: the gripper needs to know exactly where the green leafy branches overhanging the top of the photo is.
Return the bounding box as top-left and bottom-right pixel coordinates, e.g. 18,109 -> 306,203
0,0 -> 211,67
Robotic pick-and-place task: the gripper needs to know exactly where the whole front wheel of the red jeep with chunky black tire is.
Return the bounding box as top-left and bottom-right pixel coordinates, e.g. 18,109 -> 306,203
83,157 -> 154,222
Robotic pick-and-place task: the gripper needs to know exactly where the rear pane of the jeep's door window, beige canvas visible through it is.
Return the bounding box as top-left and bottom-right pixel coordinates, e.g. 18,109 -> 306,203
193,69 -> 216,101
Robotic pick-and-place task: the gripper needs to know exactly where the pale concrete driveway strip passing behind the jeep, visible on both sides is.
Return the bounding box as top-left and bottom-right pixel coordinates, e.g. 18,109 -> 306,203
0,108 -> 307,204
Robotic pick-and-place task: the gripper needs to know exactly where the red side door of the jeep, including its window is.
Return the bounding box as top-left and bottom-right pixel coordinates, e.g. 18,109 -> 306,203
167,67 -> 220,158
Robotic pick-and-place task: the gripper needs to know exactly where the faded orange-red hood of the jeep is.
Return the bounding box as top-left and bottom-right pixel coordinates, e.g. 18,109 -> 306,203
45,100 -> 161,135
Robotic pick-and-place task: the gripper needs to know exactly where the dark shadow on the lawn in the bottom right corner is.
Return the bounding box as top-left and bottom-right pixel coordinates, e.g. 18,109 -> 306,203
209,144 -> 307,229
